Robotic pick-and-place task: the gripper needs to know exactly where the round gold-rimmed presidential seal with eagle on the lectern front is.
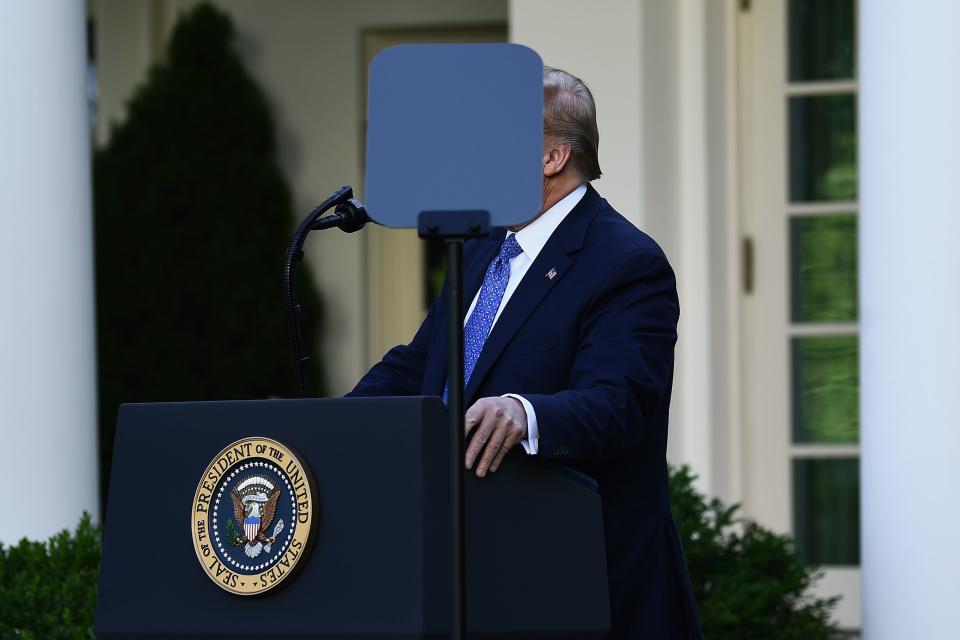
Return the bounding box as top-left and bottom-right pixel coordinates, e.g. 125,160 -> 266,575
190,438 -> 317,596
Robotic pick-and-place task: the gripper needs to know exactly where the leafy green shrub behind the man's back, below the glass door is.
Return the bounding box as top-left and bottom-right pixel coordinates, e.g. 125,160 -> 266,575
670,466 -> 839,640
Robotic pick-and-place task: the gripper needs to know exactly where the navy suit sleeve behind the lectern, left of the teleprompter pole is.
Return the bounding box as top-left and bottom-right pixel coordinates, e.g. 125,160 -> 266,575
346,295 -> 443,398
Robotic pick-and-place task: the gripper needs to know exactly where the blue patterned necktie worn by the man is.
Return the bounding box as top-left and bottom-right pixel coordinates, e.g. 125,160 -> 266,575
443,233 -> 523,404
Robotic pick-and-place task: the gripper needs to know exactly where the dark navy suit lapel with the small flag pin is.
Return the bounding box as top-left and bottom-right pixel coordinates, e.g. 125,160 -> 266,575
464,187 -> 600,403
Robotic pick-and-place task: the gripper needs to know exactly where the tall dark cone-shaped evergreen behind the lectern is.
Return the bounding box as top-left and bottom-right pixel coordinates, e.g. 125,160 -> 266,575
94,5 -> 322,500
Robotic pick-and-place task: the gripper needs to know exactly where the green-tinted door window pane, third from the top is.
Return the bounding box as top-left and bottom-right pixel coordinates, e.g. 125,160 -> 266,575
790,214 -> 857,322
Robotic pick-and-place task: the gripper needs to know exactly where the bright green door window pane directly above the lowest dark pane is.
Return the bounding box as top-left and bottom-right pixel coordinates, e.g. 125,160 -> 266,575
791,336 -> 860,443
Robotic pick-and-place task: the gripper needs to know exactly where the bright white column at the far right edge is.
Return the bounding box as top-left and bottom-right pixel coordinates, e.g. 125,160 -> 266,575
859,0 -> 960,640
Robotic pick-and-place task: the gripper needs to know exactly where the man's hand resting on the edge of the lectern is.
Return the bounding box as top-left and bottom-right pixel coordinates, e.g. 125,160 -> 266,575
464,398 -> 527,478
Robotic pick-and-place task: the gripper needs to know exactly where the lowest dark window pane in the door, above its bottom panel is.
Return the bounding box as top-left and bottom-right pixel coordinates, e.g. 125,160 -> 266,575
793,458 -> 860,565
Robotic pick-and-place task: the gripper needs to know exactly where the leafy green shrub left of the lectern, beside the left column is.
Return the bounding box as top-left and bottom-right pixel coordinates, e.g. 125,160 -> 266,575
0,515 -> 100,640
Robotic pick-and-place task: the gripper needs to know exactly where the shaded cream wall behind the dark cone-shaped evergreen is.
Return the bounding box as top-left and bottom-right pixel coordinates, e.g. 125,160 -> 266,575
97,0 -> 507,394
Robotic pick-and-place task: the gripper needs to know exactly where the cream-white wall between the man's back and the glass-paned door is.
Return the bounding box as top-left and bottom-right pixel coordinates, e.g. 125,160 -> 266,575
510,0 -> 739,498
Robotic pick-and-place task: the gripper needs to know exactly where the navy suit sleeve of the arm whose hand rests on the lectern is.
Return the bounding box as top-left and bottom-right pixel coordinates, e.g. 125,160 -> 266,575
524,250 -> 680,461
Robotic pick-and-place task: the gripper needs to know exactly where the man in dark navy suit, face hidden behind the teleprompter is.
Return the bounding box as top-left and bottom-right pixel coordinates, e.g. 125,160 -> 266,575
350,68 -> 700,640
